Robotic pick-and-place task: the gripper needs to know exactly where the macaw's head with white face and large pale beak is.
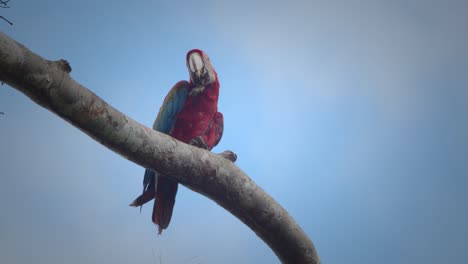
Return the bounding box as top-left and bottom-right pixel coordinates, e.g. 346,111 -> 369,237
187,49 -> 218,95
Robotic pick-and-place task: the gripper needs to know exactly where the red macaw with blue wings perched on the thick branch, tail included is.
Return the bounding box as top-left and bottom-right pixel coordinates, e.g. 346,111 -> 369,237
130,49 -> 223,234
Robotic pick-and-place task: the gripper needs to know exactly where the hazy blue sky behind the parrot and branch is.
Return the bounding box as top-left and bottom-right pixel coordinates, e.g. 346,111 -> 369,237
0,0 -> 468,264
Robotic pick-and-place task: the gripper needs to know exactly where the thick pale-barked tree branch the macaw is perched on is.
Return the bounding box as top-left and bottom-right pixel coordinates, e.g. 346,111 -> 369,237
0,32 -> 320,263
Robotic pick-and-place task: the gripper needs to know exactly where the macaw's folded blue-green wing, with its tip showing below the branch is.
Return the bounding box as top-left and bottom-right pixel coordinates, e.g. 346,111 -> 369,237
143,81 -> 190,197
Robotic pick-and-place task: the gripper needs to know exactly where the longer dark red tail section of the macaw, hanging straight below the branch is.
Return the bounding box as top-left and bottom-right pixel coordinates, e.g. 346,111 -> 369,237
153,177 -> 178,234
